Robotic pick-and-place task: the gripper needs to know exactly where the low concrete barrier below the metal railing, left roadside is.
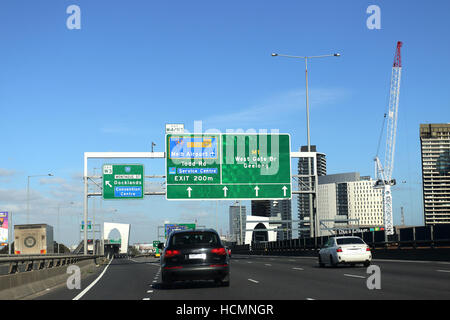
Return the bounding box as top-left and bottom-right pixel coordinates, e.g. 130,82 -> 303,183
0,258 -> 104,300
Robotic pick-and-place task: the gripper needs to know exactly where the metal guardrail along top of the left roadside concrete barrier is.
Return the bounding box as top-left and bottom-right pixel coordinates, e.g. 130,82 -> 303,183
0,254 -> 102,275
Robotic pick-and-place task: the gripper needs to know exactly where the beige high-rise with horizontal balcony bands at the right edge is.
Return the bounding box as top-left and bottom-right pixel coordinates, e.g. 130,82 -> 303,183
420,123 -> 450,225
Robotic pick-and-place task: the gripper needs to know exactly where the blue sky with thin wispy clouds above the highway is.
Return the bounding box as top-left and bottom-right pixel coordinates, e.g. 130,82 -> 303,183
0,0 -> 450,245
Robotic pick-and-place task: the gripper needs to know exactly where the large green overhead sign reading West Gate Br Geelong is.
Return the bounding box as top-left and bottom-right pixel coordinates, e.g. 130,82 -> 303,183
166,133 -> 292,200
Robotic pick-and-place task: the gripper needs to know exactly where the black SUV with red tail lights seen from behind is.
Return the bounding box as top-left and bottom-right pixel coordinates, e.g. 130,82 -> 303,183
161,229 -> 230,286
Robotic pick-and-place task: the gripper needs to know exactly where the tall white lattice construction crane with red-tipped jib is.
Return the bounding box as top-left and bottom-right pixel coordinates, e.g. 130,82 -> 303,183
374,41 -> 403,235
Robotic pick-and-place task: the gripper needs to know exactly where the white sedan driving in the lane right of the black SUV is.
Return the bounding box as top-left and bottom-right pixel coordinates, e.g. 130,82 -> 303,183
319,237 -> 372,267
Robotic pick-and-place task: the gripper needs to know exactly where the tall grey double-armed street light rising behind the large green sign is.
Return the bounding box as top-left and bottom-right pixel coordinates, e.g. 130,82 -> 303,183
272,53 -> 341,238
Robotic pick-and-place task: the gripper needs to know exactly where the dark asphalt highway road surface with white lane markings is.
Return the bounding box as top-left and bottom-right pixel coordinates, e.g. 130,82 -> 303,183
36,255 -> 450,300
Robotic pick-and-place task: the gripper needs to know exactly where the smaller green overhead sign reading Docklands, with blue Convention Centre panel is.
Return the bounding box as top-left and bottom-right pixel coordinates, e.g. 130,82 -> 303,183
102,164 -> 144,200
